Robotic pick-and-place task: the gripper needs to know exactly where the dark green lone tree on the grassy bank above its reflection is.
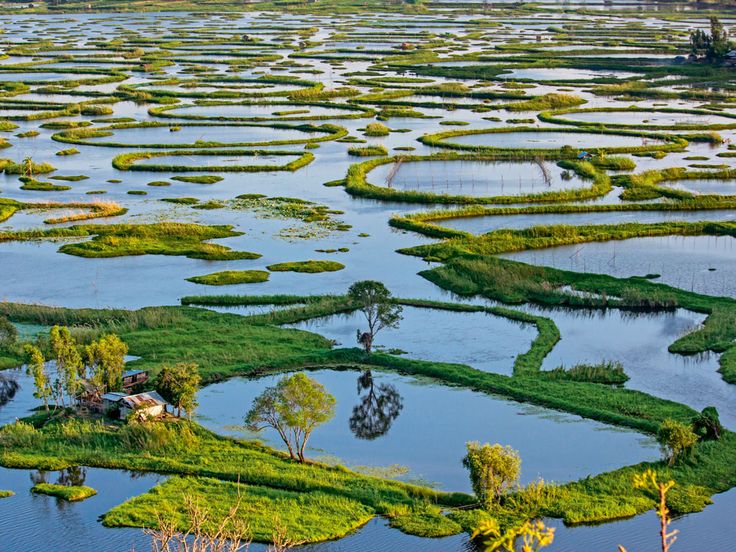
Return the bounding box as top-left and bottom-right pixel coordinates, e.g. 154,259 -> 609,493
348,280 -> 402,353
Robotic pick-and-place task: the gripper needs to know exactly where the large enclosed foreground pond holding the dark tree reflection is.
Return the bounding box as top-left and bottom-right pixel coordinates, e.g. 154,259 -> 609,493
197,370 -> 660,492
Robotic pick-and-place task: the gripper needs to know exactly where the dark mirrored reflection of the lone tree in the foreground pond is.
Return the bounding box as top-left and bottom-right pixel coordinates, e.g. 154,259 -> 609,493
350,370 -> 404,440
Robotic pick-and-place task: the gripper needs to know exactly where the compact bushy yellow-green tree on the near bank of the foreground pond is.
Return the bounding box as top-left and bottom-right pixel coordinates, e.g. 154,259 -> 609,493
463,441 -> 521,508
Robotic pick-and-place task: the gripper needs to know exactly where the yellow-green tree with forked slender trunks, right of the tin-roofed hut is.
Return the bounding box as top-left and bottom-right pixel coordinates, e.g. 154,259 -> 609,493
245,374 -> 335,462
